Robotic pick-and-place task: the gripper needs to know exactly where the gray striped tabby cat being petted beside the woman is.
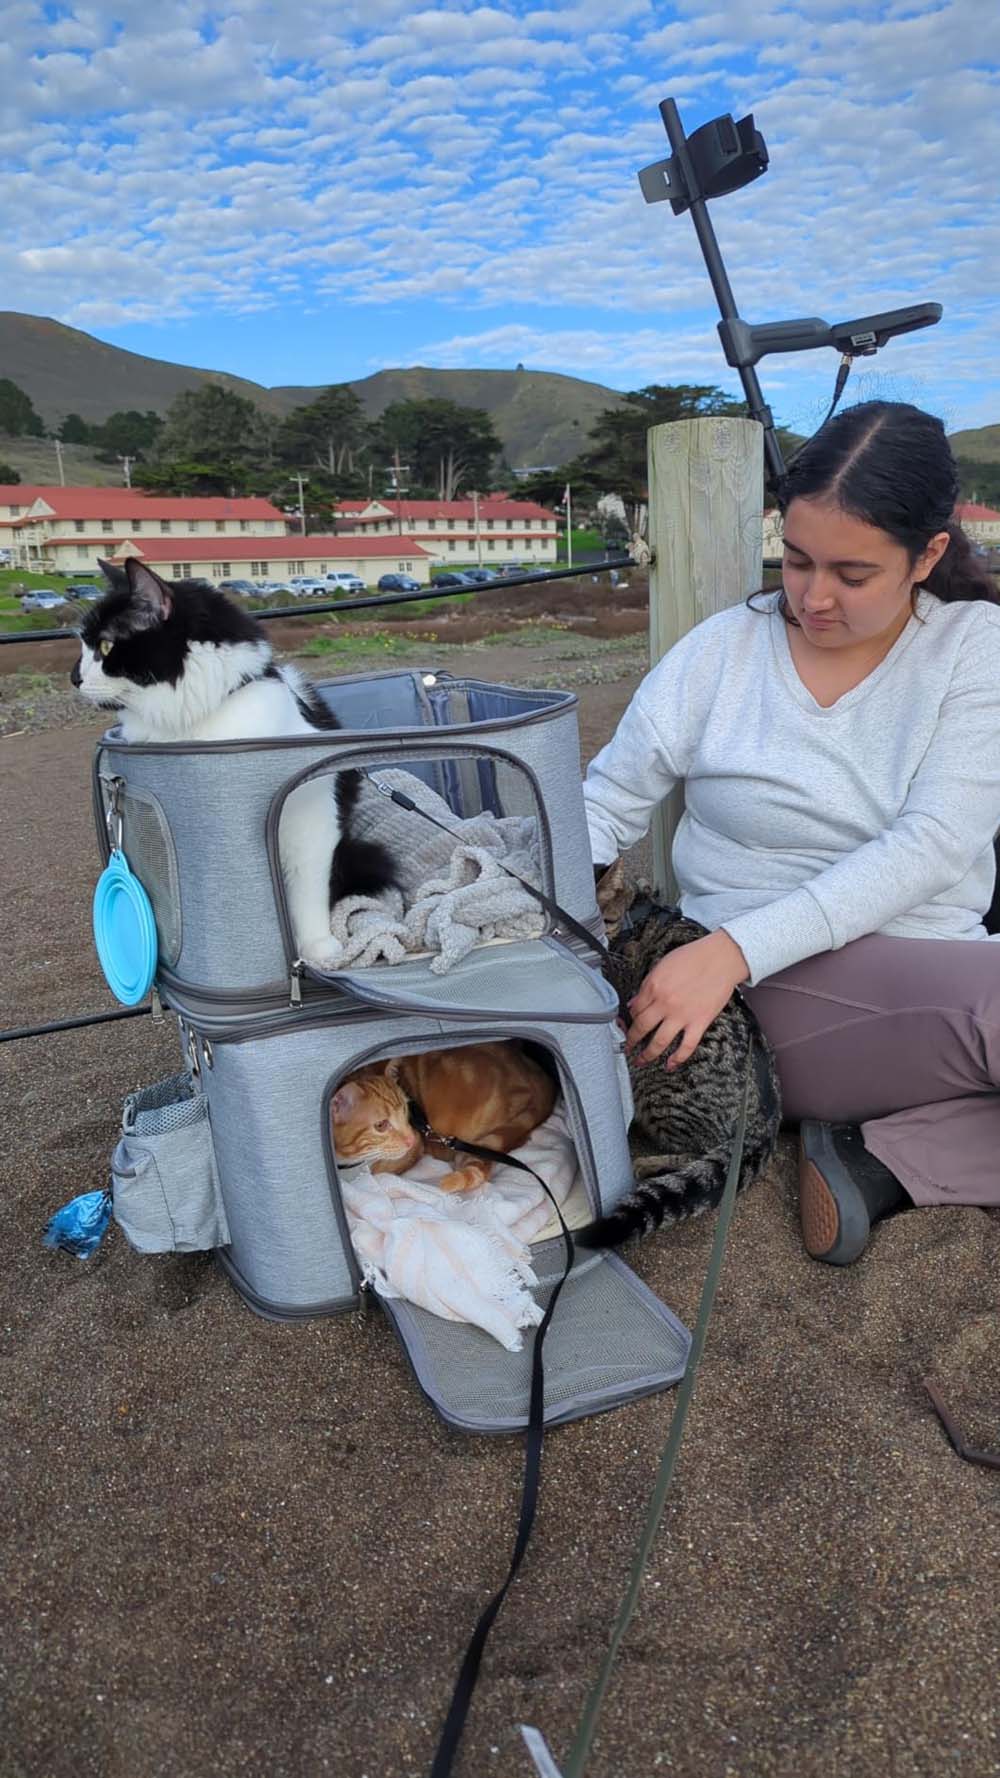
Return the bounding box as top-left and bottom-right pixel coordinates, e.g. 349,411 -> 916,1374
573,859 -> 781,1246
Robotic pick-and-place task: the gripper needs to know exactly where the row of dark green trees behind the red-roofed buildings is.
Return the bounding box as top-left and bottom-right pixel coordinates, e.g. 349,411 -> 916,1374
0,364 -> 1000,533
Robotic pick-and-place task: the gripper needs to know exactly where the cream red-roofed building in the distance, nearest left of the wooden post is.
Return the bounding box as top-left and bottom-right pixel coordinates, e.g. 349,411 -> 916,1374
336,494 -> 559,565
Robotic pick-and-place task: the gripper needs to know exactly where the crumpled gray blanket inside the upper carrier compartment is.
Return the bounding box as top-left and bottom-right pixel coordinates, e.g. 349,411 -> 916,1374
331,768 -> 544,974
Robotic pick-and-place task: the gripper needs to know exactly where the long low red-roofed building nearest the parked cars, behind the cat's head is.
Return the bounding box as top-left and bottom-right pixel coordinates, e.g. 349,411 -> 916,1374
65,535 -> 431,585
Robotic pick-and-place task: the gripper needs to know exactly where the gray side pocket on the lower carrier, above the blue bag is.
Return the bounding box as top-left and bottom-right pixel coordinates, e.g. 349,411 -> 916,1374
110,1074 -> 230,1253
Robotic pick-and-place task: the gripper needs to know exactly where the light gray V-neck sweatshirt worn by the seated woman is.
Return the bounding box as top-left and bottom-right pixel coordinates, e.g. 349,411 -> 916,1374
584,594 -> 1000,983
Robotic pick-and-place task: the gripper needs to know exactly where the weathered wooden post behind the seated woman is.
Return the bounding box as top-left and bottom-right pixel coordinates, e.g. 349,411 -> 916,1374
648,408 -> 763,900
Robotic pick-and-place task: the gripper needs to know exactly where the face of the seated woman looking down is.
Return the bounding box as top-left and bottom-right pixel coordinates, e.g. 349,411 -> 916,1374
781,500 -> 948,651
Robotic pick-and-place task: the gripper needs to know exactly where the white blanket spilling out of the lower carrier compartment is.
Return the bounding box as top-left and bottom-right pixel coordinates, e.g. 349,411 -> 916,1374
340,1104 -> 589,1351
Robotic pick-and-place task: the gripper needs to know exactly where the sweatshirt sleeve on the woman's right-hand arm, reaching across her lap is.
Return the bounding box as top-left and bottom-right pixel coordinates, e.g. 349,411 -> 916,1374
722,617 -> 1000,985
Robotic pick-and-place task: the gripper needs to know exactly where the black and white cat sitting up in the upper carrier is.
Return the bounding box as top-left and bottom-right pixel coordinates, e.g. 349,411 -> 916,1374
69,557 -> 397,969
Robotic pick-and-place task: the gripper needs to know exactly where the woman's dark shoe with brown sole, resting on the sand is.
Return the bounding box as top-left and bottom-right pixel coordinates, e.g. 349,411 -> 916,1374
799,1118 -> 906,1266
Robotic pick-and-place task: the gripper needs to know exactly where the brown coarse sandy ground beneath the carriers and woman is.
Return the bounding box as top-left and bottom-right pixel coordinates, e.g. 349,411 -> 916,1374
0,649 -> 1000,1778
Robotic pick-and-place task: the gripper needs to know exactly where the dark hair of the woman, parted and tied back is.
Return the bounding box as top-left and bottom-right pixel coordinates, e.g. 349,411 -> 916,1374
758,402 -> 1000,605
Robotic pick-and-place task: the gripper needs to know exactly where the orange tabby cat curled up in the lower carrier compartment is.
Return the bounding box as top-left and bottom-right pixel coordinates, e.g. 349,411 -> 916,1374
329,1044 -> 557,1191
